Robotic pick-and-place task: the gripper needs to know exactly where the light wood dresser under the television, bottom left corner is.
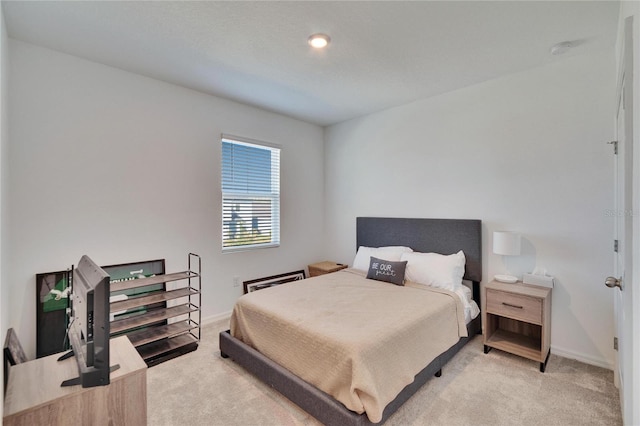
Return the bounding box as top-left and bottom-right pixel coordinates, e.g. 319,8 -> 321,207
3,336 -> 147,426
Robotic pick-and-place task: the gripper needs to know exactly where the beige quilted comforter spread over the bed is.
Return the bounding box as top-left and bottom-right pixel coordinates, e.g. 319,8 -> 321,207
231,269 -> 467,423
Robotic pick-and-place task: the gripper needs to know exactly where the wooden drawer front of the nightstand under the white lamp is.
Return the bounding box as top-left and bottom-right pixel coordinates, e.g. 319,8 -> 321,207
487,289 -> 542,324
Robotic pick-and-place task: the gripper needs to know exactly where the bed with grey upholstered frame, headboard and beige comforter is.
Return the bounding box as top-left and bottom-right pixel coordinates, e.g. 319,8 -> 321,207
220,217 -> 482,425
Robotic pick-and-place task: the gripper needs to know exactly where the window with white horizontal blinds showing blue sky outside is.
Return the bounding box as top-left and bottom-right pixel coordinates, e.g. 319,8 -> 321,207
222,135 -> 280,251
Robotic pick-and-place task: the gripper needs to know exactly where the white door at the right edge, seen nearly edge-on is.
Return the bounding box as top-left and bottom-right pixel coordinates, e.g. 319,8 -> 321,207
606,16 -> 640,425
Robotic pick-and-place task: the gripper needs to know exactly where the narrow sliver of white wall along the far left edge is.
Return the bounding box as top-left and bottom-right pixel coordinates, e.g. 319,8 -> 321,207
0,2 -> 11,415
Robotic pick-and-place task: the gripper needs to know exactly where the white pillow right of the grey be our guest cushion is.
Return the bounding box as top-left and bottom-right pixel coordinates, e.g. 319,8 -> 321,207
400,250 -> 466,291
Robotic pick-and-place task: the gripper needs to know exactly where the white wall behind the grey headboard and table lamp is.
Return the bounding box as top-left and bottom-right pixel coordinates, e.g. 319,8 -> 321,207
325,49 -> 615,367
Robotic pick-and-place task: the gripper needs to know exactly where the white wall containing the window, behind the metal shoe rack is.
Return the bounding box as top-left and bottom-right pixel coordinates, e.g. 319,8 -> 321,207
10,40 -> 324,355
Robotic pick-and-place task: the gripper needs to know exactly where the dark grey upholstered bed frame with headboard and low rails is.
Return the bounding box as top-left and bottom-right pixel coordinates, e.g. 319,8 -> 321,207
220,217 -> 482,426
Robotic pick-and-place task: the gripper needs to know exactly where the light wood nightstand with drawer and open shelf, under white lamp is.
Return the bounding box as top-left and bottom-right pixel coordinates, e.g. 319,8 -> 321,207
483,281 -> 551,373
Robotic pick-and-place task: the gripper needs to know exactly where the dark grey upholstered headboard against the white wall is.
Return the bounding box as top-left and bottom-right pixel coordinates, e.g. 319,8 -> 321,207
356,217 -> 482,283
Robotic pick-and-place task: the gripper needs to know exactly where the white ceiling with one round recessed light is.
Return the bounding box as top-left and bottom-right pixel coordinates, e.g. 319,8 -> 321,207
2,0 -> 619,125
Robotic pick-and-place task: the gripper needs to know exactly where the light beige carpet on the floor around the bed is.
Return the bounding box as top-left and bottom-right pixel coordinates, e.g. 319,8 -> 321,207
147,321 -> 622,426
